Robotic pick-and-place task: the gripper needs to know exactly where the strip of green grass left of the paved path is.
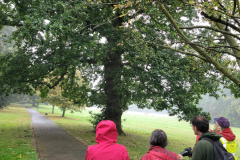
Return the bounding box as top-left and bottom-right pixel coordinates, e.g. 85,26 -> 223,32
0,104 -> 37,160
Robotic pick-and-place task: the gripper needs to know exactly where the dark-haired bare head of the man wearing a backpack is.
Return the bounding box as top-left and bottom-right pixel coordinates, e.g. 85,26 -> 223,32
191,116 -> 209,135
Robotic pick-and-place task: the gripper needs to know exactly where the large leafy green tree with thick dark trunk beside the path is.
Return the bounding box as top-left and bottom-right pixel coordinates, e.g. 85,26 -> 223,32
0,0 -> 223,134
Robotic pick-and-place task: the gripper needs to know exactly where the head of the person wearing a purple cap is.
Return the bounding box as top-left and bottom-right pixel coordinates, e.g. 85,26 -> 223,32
213,117 -> 230,132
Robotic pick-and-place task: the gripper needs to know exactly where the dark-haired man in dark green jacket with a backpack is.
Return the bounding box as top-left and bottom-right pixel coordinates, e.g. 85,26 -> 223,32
191,116 -> 222,160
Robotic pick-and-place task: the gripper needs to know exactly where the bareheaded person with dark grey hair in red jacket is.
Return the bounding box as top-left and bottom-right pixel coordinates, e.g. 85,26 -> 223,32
140,129 -> 183,160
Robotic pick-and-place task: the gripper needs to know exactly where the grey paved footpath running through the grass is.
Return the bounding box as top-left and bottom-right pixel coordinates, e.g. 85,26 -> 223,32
25,106 -> 87,160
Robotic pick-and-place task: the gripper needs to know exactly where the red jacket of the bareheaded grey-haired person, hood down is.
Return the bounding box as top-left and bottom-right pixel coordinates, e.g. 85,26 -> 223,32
140,146 -> 177,160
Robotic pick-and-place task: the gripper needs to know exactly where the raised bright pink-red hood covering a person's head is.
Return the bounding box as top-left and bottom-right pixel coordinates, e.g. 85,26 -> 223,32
95,120 -> 118,143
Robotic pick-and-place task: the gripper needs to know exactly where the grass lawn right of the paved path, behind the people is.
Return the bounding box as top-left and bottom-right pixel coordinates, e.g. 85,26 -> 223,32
31,105 -> 240,159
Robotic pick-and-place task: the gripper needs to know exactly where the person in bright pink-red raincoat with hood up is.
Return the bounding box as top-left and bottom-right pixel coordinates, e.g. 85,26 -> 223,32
85,120 -> 129,160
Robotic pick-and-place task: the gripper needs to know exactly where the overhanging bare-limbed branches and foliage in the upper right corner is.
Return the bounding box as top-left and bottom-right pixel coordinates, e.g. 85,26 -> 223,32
127,0 -> 240,97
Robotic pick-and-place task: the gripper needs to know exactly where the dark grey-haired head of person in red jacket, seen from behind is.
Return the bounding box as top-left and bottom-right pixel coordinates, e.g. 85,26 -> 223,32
149,129 -> 168,148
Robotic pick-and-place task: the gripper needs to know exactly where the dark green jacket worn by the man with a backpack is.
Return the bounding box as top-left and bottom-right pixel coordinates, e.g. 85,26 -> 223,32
191,132 -> 222,160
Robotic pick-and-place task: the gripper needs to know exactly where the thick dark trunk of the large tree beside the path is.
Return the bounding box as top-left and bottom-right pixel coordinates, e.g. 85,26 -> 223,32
99,4 -> 124,135
